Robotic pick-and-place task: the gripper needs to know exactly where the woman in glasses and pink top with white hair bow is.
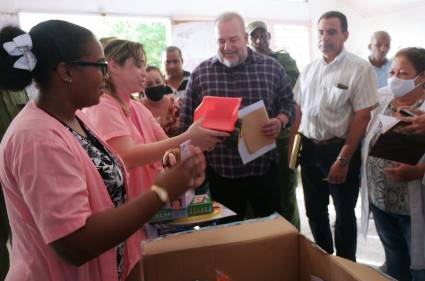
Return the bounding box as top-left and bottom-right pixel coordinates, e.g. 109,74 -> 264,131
0,20 -> 205,281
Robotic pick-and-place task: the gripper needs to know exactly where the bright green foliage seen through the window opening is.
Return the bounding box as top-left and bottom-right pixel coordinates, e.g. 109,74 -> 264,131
103,20 -> 167,68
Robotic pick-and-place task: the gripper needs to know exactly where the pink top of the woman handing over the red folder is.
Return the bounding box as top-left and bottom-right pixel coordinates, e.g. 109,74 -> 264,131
84,94 -> 166,194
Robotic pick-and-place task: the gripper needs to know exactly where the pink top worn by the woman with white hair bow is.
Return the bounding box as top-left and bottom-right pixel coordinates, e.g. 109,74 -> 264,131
0,102 -> 141,281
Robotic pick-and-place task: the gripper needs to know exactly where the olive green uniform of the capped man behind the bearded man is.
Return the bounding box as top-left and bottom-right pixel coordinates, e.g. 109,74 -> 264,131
270,51 -> 300,229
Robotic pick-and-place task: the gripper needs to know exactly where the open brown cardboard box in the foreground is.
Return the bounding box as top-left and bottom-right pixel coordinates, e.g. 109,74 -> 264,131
142,216 -> 390,281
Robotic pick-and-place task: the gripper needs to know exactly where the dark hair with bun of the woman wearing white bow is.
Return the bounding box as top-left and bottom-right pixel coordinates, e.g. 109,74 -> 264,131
0,20 -> 95,91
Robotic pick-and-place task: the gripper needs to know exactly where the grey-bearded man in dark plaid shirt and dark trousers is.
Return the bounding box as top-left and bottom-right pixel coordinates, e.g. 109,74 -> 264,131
180,12 -> 295,222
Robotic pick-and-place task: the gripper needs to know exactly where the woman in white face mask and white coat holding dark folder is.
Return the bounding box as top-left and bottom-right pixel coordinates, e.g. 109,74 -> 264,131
361,48 -> 425,281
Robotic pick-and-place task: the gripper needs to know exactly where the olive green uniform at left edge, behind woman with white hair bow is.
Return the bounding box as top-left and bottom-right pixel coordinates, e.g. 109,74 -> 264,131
0,91 -> 28,280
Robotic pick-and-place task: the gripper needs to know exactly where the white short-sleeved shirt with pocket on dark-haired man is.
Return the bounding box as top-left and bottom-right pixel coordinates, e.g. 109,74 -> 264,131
294,50 -> 378,140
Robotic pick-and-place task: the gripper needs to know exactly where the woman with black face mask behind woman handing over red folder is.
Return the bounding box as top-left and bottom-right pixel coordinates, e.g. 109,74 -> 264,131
142,66 -> 180,137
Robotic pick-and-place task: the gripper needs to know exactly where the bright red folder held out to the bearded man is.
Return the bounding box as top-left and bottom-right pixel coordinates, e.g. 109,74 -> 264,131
194,96 -> 242,132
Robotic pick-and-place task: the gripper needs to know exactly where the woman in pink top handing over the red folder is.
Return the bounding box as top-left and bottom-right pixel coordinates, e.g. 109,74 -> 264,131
84,39 -> 228,194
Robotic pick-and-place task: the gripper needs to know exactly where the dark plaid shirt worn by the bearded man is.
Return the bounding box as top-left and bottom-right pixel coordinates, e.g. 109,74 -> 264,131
180,49 -> 295,178
